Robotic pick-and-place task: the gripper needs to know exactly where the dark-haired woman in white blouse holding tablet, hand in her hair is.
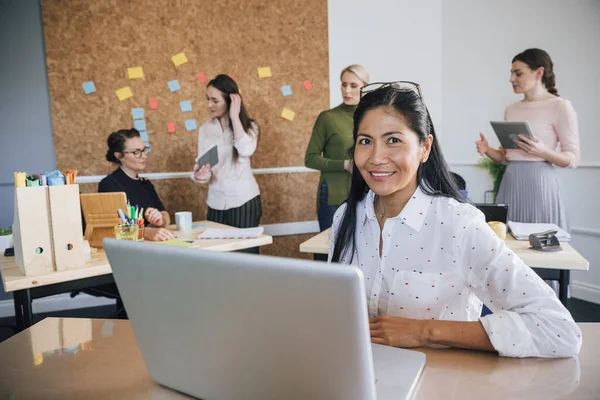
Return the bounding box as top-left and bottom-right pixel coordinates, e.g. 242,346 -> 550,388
192,74 -> 262,238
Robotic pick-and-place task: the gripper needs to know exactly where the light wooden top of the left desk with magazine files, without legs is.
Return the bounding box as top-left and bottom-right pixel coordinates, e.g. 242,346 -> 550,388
0,221 -> 273,292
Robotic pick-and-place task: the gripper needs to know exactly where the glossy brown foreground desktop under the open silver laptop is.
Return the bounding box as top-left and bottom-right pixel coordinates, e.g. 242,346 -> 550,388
0,318 -> 600,400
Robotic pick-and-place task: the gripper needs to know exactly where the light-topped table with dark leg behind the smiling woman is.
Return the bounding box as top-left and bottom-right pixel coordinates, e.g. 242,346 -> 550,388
300,229 -> 590,306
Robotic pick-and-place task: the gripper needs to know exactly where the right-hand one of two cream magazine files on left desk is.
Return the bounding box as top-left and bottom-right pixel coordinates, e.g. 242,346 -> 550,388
48,185 -> 86,271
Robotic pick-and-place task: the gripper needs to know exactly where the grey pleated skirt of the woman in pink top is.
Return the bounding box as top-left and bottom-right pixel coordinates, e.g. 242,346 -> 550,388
496,161 -> 569,231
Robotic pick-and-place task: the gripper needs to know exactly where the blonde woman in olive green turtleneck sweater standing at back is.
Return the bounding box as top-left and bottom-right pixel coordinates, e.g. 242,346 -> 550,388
304,64 -> 369,236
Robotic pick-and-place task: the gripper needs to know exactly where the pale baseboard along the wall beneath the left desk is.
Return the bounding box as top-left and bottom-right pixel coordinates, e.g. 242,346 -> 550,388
0,293 -> 115,318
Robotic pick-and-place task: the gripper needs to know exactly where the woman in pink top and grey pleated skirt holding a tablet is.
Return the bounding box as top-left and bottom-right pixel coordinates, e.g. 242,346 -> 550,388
475,49 -> 579,230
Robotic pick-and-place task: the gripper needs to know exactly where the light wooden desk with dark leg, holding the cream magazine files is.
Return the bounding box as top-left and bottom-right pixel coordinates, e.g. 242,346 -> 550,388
0,221 -> 273,330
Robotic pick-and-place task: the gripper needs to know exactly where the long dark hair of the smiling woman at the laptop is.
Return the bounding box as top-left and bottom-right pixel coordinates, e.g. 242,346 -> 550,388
332,87 -> 464,262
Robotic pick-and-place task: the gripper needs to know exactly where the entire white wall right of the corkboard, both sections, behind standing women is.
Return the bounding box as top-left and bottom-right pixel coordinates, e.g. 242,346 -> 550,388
329,0 -> 600,303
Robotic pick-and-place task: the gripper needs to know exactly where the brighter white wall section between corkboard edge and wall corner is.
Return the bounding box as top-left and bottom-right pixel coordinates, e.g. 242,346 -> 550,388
328,0 -> 442,127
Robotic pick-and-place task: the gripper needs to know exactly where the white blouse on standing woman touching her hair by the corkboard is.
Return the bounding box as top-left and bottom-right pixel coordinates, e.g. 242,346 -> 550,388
192,118 -> 260,210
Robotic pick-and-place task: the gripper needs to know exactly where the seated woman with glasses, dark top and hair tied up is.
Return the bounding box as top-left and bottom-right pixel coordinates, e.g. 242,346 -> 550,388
98,129 -> 173,241
